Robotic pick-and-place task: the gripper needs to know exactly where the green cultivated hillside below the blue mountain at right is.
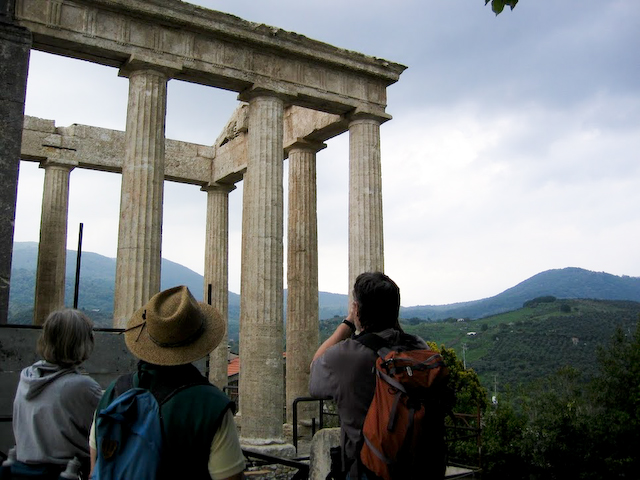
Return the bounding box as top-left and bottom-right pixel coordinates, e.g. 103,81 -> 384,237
404,297 -> 640,390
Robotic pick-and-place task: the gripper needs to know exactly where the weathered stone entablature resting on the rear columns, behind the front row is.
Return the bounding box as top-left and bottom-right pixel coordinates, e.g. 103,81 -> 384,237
21,104 -> 347,186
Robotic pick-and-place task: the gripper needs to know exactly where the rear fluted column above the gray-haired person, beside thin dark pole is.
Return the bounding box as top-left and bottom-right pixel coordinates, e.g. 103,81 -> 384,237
33,162 -> 74,325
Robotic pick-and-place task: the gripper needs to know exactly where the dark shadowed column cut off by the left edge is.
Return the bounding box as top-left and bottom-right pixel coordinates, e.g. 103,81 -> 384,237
0,20 -> 31,323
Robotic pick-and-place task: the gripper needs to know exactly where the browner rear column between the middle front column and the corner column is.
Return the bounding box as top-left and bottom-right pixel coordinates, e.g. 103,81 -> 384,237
286,141 -> 326,424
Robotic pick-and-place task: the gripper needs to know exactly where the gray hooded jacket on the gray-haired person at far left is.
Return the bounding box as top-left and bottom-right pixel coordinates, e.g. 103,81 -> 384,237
13,360 -> 102,464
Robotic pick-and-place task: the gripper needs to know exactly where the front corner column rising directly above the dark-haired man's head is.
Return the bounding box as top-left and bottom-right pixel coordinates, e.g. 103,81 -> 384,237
349,116 -> 384,294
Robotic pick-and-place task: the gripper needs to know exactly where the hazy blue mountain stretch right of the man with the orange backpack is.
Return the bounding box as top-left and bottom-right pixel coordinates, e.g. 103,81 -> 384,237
401,267 -> 640,320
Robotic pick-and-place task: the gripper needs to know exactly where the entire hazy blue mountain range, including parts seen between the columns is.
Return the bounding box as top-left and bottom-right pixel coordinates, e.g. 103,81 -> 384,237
9,242 -> 640,326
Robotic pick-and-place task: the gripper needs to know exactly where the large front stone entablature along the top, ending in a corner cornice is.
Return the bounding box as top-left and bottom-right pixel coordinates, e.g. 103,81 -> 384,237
15,0 -> 406,119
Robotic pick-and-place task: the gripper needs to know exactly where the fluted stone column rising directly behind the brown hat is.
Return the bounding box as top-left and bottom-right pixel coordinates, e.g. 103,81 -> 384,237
113,69 -> 168,327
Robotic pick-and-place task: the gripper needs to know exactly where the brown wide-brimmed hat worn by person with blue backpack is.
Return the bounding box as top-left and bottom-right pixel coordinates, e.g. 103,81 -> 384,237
124,286 -> 226,365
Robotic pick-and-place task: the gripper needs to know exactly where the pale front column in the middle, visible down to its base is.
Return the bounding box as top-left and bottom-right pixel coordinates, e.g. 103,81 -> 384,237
239,94 -> 284,445
